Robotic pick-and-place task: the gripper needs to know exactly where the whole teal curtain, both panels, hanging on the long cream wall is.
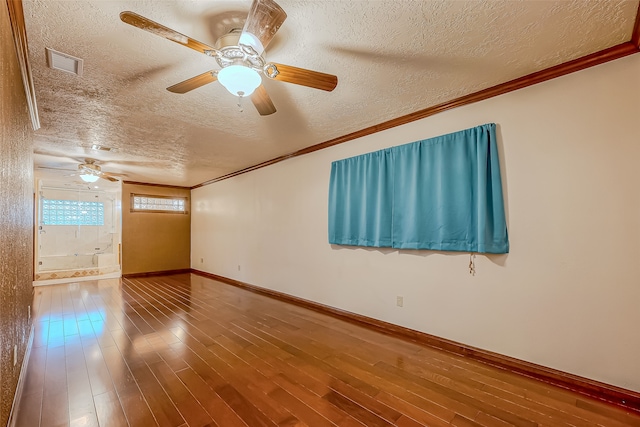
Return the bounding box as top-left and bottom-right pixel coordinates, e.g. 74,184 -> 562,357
329,123 -> 509,253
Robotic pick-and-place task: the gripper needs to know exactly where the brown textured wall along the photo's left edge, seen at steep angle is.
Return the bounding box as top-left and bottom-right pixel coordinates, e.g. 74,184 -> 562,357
0,2 -> 33,425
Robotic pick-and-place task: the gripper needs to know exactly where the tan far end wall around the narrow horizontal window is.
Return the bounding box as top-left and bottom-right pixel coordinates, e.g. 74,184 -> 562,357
122,183 -> 191,274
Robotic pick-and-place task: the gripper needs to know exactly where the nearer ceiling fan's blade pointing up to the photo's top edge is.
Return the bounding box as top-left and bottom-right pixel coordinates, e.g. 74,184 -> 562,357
239,0 -> 287,55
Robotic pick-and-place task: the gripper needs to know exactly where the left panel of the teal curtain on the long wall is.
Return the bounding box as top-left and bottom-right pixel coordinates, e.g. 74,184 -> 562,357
329,149 -> 393,247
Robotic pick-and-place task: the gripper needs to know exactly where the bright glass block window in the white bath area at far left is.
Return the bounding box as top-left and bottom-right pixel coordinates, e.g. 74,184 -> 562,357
42,199 -> 104,225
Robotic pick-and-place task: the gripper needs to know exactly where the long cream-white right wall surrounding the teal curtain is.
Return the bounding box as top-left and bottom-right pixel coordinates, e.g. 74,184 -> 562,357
191,55 -> 640,391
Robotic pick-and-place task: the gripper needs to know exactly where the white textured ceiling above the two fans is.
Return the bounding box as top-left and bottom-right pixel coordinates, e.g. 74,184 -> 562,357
23,0 -> 638,186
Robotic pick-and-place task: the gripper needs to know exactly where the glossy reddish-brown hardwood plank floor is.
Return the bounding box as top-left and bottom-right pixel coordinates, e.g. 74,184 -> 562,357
16,274 -> 640,427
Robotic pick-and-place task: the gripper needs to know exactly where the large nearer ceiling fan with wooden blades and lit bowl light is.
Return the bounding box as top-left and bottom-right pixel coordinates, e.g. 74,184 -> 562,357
120,0 -> 338,116
